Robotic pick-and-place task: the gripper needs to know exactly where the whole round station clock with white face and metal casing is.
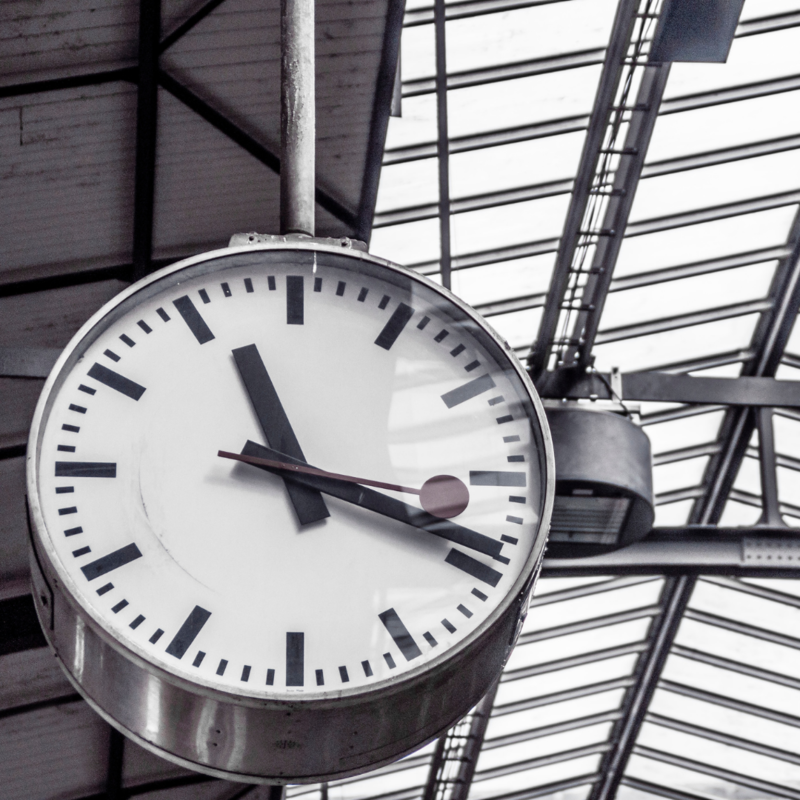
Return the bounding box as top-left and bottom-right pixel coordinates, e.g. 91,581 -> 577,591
28,239 -> 553,783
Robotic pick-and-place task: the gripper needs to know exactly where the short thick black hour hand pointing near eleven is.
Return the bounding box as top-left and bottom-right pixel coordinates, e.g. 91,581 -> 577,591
233,344 -> 331,525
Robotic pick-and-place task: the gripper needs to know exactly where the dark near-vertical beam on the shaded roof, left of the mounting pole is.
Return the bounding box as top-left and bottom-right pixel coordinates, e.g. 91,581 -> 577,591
131,0 -> 161,280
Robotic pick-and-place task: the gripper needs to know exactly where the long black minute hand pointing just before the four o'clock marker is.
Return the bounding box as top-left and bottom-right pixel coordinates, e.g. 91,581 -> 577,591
236,441 -> 503,558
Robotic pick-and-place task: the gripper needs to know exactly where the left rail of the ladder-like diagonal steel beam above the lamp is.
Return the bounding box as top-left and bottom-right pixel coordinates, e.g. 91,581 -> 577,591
528,0 -> 639,378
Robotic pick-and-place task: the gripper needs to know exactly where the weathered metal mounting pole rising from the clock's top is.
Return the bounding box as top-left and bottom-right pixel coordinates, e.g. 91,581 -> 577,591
281,0 -> 316,236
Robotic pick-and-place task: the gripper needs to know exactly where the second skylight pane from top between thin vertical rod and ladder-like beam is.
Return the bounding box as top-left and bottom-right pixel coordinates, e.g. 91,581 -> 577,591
447,66 -> 600,137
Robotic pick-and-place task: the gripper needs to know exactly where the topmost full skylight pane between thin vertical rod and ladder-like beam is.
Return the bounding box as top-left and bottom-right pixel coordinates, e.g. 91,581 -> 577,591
447,0 -> 616,72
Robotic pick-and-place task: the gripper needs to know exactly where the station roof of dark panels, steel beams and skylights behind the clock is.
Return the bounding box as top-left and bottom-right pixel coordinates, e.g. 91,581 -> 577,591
0,0 -> 800,800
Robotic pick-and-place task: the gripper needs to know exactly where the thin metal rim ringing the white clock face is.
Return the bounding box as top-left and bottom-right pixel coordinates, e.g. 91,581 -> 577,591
26,238 -> 555,708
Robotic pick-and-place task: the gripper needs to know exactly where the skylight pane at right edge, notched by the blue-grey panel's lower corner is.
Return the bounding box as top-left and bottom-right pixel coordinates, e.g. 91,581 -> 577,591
665,28 -> 800,98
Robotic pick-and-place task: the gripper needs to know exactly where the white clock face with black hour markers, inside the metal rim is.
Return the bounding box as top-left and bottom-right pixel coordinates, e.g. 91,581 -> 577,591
36,250 -> 545,697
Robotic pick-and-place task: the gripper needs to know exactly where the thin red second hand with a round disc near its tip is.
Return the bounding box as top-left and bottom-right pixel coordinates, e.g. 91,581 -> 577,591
217,450 -> 469,519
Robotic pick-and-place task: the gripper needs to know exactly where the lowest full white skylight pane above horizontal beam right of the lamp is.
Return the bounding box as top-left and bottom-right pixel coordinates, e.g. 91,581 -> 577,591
592,313 -> 759,372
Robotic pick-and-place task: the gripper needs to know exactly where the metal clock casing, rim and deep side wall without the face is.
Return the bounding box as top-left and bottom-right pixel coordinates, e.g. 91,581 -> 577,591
23,241 -> 554,784
